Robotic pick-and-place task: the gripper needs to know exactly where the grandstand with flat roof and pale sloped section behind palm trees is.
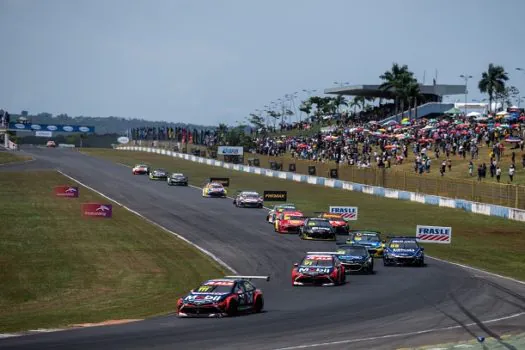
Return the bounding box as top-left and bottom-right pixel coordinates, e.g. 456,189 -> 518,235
324,84 -> 467,122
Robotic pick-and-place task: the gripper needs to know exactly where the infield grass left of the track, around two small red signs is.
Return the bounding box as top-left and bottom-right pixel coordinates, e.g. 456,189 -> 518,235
0,171 -> 225,332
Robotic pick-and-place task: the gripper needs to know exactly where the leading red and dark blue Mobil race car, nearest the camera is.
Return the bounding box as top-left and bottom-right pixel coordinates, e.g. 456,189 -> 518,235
177,276 -> 270,317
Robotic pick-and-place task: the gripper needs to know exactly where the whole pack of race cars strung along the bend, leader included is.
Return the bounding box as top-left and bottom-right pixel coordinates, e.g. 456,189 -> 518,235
132,164 -> 425,317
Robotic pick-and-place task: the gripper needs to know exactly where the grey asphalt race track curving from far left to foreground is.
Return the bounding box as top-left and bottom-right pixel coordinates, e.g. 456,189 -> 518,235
0,148 -> 525,350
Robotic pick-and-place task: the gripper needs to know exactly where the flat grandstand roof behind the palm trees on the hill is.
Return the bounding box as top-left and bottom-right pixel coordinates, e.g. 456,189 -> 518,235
324,84 -> 467,99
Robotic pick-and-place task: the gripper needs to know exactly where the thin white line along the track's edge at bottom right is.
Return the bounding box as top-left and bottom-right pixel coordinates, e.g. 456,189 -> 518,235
274,311 -> 525,350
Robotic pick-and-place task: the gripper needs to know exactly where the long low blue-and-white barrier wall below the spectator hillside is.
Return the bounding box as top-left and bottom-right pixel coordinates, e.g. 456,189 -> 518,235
117,146 -> 525,222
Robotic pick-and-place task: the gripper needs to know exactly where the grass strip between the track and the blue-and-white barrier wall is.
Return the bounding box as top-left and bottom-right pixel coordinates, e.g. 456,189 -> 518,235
85,149 -> 525,280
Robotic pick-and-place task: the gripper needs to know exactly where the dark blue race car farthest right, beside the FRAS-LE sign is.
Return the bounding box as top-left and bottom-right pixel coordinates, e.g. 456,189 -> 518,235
383,237 -> 425,266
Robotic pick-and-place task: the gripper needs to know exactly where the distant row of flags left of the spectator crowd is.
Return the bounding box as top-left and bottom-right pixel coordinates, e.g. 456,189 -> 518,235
128,126 -> 215,145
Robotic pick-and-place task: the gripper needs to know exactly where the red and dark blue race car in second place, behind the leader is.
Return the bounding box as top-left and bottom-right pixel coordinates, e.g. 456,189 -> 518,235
292,252 -> 346,286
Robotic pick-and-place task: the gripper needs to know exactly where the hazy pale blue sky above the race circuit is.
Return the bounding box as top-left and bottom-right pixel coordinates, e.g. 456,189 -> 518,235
0,0 -> 525,125
